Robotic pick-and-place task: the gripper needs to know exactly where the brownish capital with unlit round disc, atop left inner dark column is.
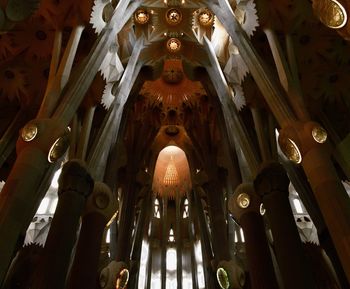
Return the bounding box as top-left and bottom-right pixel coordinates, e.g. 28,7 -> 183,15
84,182 -> 118,223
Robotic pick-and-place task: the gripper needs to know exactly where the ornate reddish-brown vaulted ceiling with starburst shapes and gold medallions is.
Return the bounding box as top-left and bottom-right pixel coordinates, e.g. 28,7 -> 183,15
0,0 -> 350,181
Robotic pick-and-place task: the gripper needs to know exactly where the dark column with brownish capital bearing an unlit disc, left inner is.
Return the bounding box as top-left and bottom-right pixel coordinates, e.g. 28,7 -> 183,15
67,182 -> 117,289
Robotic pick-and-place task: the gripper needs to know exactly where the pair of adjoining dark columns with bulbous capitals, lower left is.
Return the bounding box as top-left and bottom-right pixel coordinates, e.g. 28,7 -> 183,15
0,160 -> 117,289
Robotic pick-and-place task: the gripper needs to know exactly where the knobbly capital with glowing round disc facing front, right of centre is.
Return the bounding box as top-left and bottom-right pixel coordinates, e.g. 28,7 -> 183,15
228,183 -> 262,222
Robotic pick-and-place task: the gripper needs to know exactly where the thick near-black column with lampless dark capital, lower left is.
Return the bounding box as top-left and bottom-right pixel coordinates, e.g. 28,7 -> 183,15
32,160 -> 94,289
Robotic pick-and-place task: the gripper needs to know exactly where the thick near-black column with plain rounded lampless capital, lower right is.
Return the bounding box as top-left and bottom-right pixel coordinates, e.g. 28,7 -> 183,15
254,162 -> 315,289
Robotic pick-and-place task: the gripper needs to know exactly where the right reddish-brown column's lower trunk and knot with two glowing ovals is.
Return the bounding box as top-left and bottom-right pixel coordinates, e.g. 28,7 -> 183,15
278,122 -> 350,281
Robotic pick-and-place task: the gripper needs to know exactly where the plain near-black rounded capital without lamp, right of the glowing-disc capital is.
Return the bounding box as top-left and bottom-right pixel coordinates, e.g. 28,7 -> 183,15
254,162 -> 289,197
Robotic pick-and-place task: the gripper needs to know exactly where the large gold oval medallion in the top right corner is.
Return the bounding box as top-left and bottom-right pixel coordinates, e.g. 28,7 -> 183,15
318,0 -> 348,29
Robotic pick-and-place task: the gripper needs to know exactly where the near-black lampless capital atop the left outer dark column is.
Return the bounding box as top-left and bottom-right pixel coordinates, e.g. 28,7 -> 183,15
58,160 -> 94,198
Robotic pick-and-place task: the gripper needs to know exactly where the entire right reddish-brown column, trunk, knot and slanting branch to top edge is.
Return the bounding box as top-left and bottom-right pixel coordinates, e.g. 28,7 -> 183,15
203,0 -> 350,281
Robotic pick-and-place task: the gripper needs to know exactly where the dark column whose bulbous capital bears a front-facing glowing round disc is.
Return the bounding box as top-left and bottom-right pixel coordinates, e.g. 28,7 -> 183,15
229,183 -> 278,289
